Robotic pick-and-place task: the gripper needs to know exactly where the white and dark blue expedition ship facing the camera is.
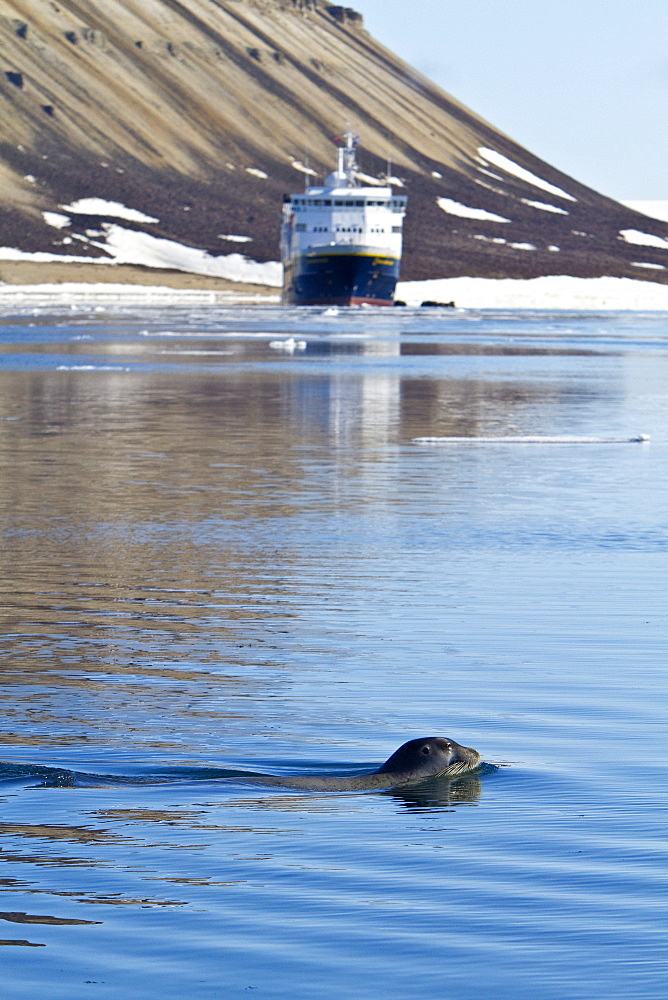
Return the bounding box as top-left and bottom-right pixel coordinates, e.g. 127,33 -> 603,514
281,129 -> 407,306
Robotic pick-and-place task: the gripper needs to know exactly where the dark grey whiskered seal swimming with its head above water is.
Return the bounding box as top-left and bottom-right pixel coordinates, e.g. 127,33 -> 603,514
235,736 -> 481,792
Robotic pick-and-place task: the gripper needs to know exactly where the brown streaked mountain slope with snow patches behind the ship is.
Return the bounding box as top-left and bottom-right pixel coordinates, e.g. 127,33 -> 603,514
0,0 -> 668,282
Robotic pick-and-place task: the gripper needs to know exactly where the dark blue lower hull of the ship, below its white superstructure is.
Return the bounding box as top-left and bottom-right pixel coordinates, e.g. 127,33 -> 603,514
283,247 -> 399,306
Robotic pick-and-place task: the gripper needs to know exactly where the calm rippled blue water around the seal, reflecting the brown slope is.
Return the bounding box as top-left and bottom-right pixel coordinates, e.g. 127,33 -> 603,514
0,306 -> 668,1000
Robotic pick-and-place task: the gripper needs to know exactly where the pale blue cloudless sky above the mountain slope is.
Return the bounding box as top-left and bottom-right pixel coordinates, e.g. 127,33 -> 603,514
352,0 -> 668,200
